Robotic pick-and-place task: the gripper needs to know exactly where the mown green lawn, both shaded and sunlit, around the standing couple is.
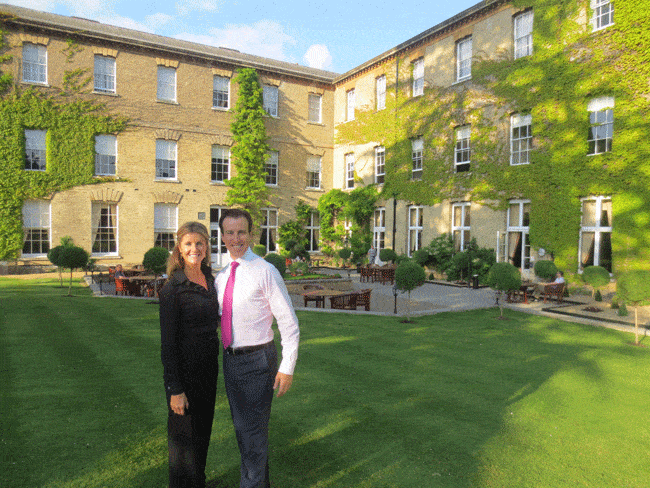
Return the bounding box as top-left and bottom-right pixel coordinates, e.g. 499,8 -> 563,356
0,278 -> 650,488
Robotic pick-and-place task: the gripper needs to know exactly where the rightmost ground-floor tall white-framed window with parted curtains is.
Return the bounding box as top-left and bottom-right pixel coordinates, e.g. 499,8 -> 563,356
580,197 -> 612,273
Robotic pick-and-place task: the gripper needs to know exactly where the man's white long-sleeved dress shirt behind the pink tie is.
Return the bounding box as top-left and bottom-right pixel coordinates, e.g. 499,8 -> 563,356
215,248 -> 300,374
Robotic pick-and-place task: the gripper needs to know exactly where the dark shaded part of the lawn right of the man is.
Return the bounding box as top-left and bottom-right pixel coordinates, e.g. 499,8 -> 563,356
264,311 -> 600,487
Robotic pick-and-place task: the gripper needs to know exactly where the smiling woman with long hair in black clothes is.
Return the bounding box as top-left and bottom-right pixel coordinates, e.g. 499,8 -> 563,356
159,222 -> 219,488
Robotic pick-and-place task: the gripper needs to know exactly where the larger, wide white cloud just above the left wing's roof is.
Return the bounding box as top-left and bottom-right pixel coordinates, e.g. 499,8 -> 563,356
176,20 -> 296,61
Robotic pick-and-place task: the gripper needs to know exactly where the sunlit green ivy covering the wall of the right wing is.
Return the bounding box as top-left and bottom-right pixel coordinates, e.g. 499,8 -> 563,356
336,0 -> 650,272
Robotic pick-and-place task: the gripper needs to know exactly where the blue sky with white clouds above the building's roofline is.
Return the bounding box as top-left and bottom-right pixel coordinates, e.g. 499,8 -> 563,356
5,0 -> 478,73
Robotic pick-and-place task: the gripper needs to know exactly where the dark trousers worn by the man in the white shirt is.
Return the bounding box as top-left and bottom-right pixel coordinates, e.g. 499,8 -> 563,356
223,342 -> 278,488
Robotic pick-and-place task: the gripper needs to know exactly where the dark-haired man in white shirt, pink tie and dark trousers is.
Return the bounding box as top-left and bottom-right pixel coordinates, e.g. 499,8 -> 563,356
215,209 -> 300,488
